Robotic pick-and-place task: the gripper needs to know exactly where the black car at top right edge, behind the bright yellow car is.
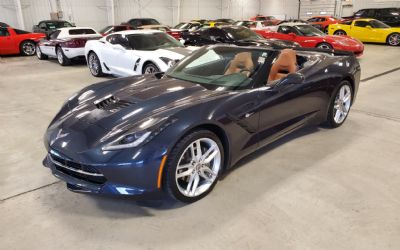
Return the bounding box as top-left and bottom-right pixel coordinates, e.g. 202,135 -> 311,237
343,8 -> 400,27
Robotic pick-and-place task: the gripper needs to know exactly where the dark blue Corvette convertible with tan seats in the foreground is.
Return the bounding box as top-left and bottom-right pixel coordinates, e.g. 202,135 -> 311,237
43,45 -> 360,202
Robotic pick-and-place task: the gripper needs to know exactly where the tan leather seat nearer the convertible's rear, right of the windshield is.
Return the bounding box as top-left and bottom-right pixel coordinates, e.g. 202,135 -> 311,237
268,49 -> 297,82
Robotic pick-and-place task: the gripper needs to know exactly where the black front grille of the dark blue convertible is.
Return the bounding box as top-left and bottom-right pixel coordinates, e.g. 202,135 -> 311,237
49,154 -> 107,184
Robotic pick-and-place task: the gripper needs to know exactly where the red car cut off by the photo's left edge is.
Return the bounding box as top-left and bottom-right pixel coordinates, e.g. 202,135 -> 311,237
0,27 -> 46,56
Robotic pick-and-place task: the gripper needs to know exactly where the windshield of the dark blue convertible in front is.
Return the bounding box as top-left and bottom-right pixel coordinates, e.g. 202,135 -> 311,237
166,46 -> 270,90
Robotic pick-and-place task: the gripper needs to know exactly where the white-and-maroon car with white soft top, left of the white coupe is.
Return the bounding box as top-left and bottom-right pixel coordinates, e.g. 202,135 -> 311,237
36,27 -> 102,66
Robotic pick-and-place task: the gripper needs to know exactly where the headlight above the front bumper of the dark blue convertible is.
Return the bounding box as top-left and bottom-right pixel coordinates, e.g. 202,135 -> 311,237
102,117 -> 177,151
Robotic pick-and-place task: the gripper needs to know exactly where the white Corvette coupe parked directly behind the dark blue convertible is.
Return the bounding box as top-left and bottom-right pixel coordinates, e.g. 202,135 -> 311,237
85,30 -> 192,76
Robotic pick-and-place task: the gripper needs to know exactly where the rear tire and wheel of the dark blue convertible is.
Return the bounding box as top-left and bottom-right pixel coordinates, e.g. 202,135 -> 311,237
326,81 -> 353,128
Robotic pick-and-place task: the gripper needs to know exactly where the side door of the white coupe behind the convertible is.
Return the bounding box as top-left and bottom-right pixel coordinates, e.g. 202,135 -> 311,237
101,34 -> 138,76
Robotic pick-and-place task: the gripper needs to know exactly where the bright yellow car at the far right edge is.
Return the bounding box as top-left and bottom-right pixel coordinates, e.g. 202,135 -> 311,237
328,18 -> 400,46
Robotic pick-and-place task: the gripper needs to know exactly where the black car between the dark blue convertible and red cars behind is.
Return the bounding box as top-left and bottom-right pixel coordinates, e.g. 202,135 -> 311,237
182,25 -> 300,47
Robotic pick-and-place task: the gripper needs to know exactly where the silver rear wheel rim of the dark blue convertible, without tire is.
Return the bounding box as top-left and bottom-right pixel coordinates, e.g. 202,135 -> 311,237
333,85 -> 351,124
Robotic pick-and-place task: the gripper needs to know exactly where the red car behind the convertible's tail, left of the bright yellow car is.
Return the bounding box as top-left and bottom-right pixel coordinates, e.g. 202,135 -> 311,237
254,23 -> 364,56
